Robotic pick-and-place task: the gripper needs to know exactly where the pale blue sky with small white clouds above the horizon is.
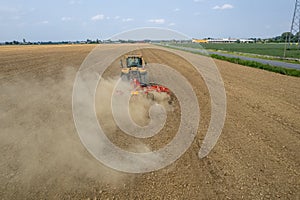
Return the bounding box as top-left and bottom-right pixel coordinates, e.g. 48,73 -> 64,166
0,0 -> 295,42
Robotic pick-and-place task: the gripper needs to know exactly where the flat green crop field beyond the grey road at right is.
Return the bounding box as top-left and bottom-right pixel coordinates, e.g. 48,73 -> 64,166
172,43 -> 300,59
